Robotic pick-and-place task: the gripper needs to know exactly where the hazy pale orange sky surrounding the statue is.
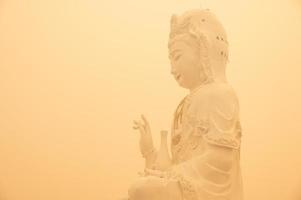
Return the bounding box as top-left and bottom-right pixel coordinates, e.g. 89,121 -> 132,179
0,0 -> 301,200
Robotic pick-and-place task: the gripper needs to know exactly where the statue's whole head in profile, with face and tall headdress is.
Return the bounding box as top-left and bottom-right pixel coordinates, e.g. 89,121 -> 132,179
168,9 -> 229,89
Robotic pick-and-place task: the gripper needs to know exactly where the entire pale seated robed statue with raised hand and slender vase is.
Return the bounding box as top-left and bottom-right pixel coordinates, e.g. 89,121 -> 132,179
128,9 -> 243,200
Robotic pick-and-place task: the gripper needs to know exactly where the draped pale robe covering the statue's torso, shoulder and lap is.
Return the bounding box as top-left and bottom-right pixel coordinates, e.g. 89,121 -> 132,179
166,83 -> 243,200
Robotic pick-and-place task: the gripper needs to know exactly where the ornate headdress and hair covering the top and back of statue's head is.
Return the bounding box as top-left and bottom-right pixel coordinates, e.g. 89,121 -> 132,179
168,9 -> 228,81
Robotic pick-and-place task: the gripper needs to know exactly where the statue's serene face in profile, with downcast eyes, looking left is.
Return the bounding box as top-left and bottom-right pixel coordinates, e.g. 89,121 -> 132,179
169,37 -> 201,89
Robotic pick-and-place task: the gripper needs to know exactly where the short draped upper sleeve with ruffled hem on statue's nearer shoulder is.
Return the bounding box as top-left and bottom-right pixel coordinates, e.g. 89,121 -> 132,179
197,88 -> 241,149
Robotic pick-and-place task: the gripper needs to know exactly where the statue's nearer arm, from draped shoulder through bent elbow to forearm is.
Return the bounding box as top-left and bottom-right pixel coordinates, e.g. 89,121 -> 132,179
173,89 -> 240,183
